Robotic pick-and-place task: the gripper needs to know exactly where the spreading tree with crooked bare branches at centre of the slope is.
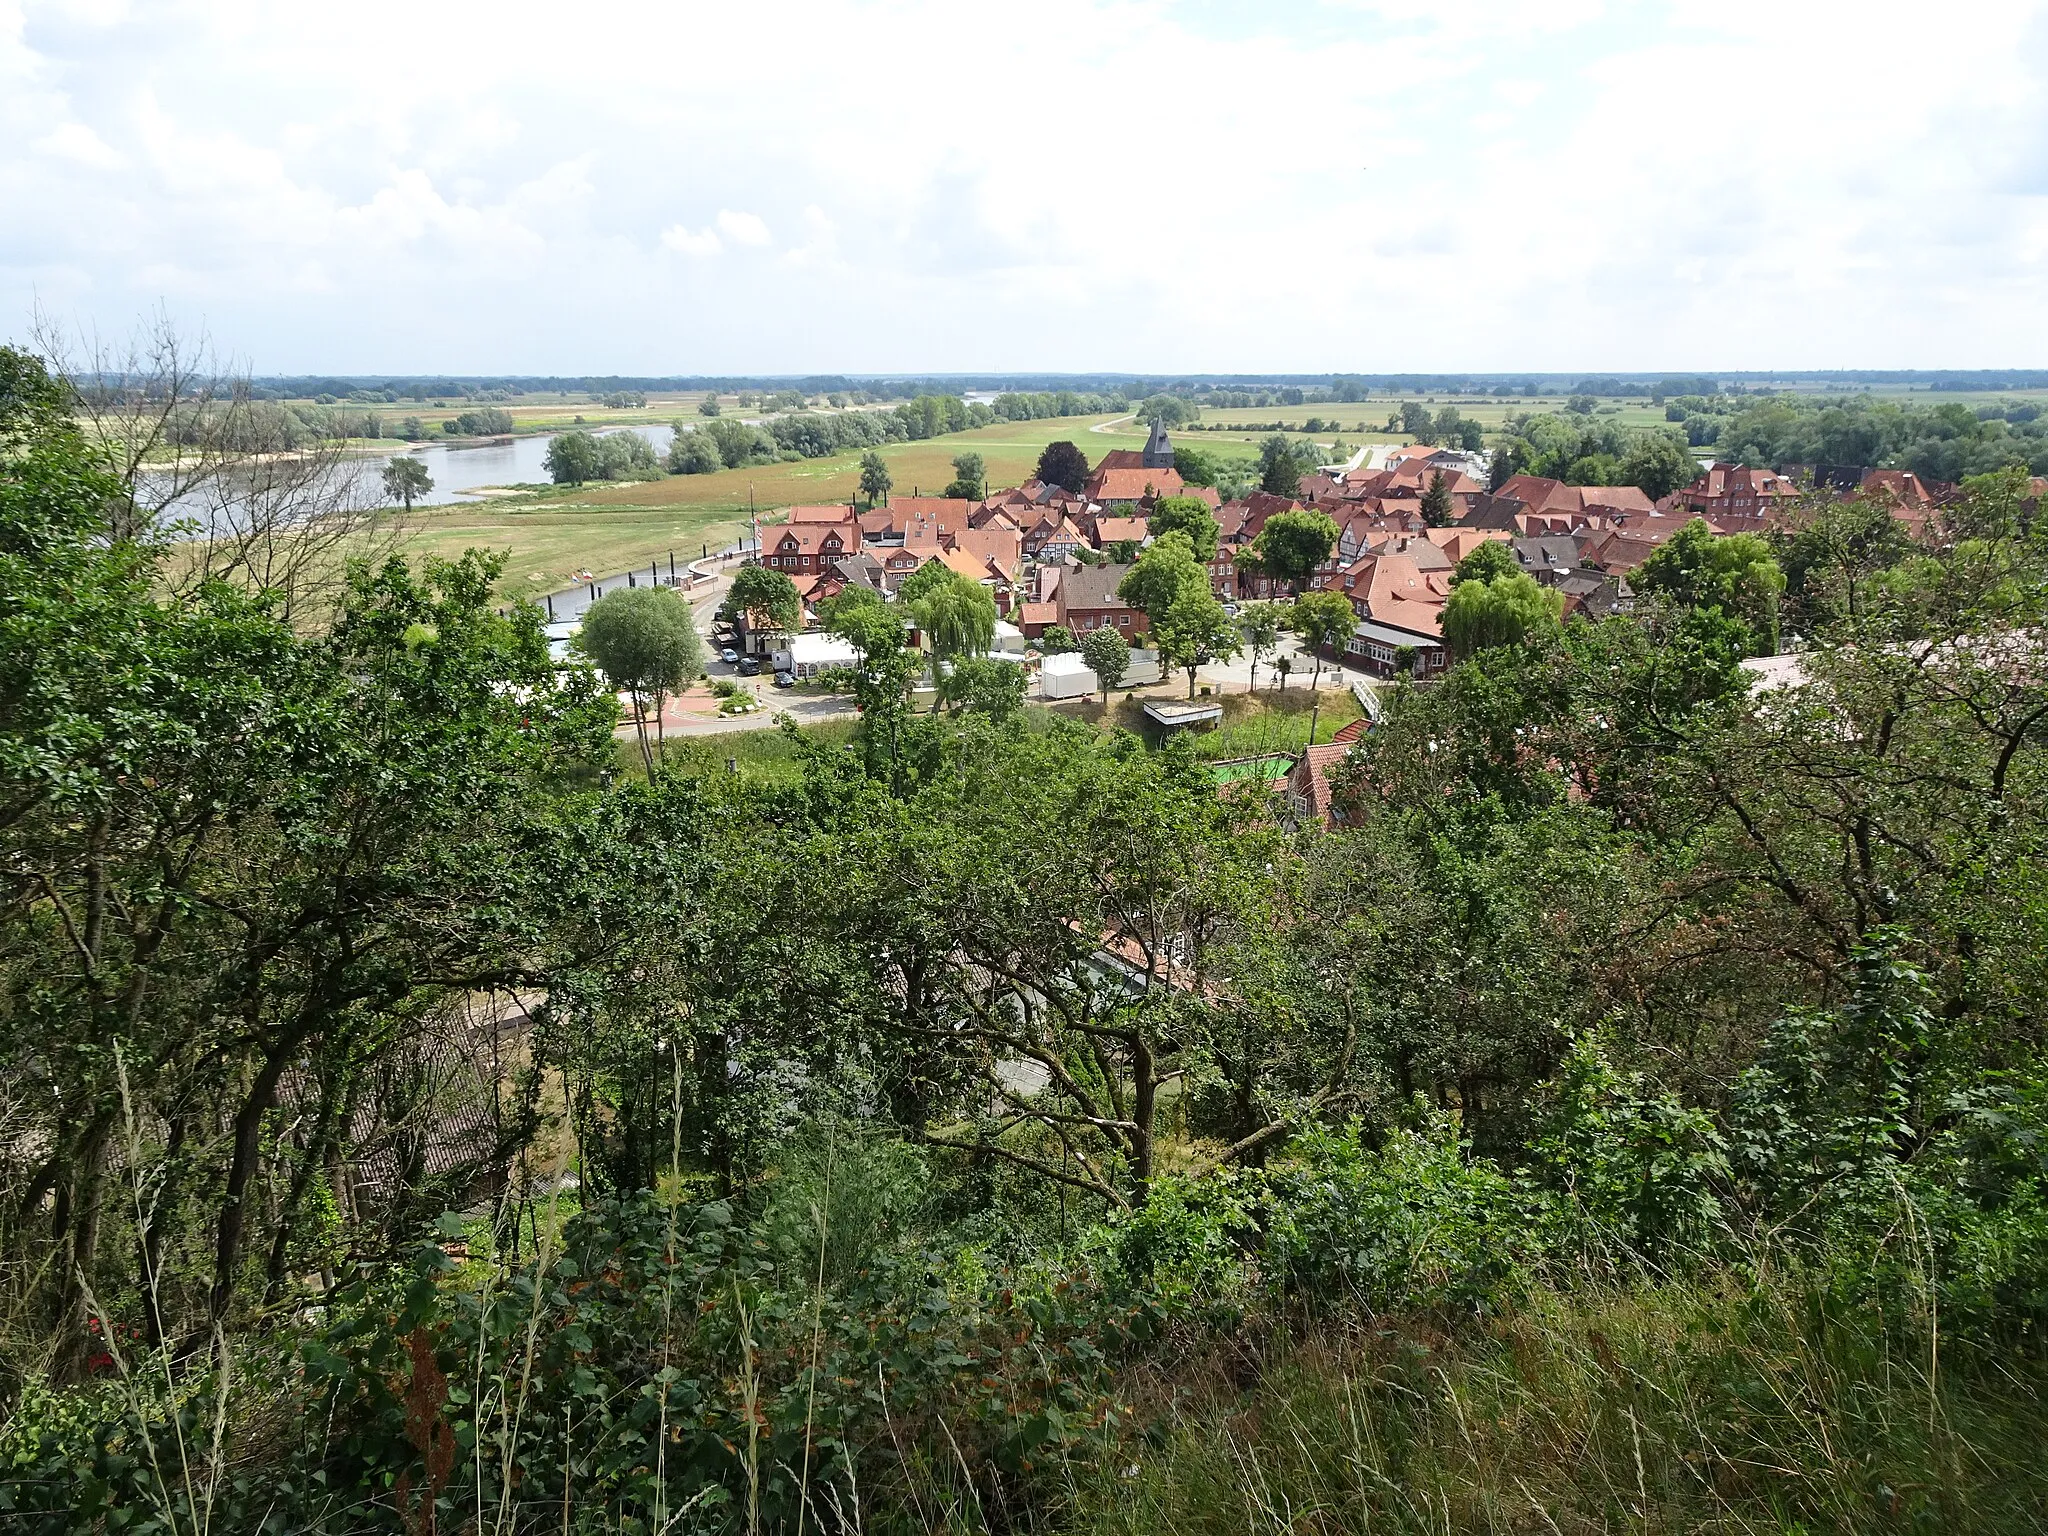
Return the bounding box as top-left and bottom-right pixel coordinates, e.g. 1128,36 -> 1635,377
905,731 -> 1286,1208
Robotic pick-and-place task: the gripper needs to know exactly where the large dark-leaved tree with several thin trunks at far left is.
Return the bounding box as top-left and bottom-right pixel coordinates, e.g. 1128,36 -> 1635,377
0,366 -> 618,1372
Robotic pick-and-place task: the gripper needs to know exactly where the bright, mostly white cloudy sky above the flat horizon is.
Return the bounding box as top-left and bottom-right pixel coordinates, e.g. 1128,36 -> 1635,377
0,0 -> 2048,375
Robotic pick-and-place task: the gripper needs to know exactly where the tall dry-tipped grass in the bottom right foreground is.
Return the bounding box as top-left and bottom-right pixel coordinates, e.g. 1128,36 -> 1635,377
1063,1284 -> 2048,1536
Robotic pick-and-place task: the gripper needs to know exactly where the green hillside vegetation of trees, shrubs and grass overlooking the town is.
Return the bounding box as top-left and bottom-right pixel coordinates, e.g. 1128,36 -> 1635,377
12,339 -> 2048,1536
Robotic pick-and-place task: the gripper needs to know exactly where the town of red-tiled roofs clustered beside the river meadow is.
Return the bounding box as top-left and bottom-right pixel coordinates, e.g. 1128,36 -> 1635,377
675,403 -> 1982,825
